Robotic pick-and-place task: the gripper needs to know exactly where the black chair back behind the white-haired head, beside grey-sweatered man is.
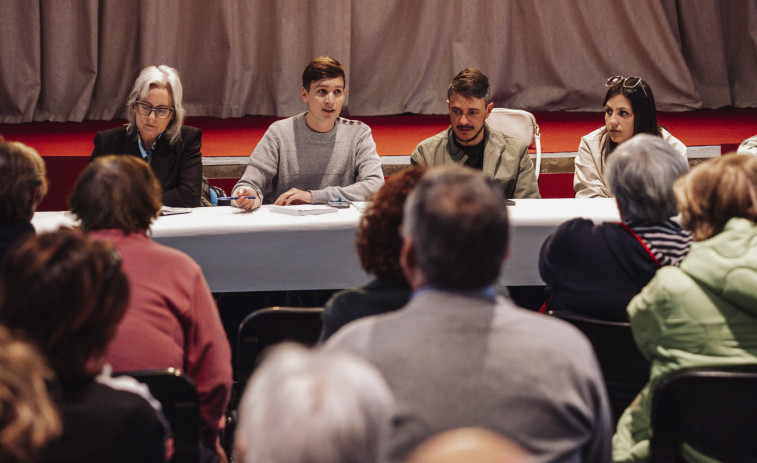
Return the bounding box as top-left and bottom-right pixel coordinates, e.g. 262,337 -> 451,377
236,307 -> 323,389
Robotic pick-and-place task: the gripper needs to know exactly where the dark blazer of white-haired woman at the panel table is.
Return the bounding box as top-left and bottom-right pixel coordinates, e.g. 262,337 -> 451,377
89,125 -> 202,207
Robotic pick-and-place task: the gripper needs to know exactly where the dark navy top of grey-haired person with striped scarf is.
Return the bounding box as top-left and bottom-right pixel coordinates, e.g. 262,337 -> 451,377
539,219 -> 660,322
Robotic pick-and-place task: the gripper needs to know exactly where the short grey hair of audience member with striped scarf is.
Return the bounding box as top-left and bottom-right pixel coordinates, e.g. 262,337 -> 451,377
606,134 -> 689,224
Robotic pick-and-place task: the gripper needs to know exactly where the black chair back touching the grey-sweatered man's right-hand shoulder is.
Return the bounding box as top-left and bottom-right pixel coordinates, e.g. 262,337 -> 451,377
550,312 -> 649,423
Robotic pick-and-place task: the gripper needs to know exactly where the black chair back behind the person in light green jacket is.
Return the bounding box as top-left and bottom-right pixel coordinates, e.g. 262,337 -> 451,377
650,365 -> 757,463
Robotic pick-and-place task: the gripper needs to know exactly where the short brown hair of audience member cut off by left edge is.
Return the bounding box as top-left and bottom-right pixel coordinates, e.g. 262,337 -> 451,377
0,138 -> 47,220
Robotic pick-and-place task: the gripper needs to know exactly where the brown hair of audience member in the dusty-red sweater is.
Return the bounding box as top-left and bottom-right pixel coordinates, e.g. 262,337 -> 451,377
68,155 -> 161,233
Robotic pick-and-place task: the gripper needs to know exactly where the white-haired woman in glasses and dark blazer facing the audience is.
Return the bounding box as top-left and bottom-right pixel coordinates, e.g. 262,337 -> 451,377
90,65 -> 202,207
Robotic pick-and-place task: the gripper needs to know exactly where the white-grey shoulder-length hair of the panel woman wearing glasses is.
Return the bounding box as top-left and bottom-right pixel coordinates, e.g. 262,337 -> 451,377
126,64 -> 184,144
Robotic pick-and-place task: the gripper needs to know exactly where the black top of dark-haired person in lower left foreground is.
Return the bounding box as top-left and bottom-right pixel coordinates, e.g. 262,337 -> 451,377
39,379 -> 165,463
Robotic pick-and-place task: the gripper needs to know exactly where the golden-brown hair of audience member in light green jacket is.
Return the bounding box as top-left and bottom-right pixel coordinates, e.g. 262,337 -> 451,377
673,154 -> 757,241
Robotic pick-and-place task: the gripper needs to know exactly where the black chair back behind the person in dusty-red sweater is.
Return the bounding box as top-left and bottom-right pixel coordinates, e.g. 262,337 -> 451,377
117,368 -> 201,463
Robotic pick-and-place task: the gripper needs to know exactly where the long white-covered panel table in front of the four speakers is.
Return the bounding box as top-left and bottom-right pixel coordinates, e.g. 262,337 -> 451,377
32,198 -> 619,292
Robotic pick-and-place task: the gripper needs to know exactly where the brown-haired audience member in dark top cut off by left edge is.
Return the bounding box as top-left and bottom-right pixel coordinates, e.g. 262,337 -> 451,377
0,137 -> 47,262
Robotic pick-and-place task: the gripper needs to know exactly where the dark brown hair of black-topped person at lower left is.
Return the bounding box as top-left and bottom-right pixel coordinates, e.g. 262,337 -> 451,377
0,229 -> 129,378
